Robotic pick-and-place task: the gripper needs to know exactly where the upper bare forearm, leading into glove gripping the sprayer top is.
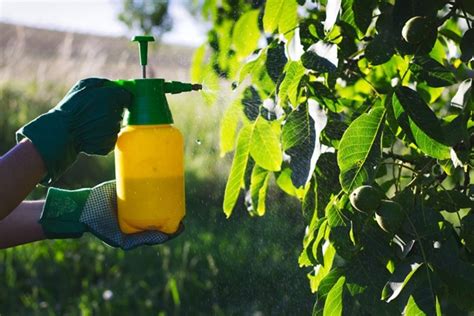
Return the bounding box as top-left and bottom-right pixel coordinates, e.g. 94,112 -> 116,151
0,139 -> 46,221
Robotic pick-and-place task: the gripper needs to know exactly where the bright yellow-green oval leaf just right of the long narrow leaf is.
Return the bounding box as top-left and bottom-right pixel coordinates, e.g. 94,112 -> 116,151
250,117 -> 283,171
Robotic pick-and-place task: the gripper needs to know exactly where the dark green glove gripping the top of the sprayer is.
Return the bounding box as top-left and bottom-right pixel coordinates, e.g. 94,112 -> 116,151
17,78 -> 132,184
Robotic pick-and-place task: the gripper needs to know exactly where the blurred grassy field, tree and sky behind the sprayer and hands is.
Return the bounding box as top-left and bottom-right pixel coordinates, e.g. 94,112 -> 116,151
0,0 -> 312,315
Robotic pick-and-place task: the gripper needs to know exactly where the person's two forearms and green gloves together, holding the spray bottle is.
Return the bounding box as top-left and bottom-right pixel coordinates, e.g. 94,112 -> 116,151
0,78 -> 178,250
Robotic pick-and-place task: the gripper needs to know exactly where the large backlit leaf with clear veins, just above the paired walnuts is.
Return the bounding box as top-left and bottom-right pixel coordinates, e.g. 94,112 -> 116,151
337,107 -> 385,193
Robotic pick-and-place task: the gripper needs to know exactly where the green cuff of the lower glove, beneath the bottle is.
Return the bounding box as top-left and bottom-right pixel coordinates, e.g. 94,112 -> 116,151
38,188 -> 91,239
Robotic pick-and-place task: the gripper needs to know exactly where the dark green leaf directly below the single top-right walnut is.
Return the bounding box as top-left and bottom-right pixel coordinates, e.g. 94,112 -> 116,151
410,56 -> 456,88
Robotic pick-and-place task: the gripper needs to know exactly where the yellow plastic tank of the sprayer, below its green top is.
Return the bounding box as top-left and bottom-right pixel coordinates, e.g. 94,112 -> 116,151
115,124 -> 185,234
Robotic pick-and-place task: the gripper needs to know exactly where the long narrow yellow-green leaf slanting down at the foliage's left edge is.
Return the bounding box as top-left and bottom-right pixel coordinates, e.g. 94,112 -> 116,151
224,125 -> 253,217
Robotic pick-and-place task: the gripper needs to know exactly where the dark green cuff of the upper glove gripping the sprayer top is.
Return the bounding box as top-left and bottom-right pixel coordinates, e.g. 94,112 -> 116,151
16,111 -> 77,185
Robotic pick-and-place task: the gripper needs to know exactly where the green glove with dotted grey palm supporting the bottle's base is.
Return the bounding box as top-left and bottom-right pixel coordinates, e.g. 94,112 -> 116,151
39,181 -> 183,250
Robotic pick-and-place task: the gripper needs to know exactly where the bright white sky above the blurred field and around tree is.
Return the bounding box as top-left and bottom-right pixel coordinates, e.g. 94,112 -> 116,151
0,0 -> 206,46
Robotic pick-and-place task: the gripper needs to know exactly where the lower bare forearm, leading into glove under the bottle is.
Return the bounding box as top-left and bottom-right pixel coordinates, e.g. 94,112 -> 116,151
0,201 -> 45,249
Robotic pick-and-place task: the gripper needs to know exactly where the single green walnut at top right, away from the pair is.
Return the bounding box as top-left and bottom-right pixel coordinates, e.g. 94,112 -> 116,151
402,16 -> 438,45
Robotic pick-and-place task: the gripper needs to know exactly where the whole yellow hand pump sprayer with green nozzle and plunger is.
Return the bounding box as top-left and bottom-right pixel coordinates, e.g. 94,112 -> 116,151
115,36 -> 202,234
